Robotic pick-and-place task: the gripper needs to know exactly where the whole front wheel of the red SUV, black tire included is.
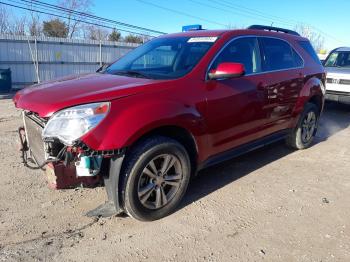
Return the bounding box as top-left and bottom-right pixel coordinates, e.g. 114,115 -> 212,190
121,136 -> 191,221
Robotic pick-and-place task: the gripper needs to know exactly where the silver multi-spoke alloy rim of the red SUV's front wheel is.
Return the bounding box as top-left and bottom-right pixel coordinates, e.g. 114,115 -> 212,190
137,154 -> 183,209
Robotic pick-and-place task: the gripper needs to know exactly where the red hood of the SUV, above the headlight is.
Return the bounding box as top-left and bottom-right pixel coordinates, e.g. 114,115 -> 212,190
13,73 -> 161,117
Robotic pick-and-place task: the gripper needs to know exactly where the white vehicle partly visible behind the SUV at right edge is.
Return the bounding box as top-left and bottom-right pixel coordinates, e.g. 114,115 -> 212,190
324,47 -> 350,104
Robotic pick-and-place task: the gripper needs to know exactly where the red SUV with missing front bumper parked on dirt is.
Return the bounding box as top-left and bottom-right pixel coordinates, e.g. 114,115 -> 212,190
14,26 -> 325,220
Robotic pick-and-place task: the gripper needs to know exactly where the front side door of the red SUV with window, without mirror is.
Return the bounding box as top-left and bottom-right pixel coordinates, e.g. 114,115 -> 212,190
205,37 -> 271,154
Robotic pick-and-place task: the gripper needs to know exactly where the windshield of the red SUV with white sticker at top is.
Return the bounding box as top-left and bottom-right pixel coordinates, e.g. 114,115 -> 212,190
104,37 -> 216,79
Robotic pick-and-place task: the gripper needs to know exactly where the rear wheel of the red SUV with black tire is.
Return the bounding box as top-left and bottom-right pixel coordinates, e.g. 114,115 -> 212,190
286,103 -> 320,150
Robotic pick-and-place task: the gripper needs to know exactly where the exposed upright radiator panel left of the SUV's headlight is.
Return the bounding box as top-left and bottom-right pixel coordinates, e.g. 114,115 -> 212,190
23,113 -> 45,164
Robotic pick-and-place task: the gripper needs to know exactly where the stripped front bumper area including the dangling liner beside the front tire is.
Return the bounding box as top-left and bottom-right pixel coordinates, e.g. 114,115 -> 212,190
18,111 -> 125,217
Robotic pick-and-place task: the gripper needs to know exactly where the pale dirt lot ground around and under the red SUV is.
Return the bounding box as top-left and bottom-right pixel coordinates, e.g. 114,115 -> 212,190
0,100 -> 350,261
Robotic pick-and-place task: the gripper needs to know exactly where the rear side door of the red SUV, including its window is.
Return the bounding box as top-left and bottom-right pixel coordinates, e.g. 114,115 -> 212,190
258,37 -> 304,128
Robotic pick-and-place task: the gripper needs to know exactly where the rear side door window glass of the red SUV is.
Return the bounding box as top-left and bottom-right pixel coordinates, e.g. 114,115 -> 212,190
259,37 -> 303,71
